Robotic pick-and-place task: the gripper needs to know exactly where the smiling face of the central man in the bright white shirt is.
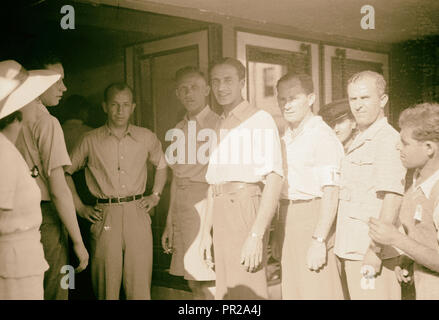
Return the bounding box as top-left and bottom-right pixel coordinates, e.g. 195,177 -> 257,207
210,64 -> 245,106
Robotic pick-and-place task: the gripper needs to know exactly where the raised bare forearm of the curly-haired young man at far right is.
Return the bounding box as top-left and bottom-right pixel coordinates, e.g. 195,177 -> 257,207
394,233 -> 439,272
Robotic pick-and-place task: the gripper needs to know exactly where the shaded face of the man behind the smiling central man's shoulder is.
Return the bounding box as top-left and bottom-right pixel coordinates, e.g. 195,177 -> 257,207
176,73 -> 210,114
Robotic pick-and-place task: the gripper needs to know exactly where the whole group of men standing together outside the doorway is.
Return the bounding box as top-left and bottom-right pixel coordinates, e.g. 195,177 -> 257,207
0,52 -> 439,300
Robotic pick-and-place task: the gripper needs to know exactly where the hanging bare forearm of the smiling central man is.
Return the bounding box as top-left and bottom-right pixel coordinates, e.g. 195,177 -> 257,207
251,173 -> 282,236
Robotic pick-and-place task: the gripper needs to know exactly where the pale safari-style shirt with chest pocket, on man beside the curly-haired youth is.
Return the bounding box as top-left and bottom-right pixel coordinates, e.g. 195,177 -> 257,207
334,118 -> 406,260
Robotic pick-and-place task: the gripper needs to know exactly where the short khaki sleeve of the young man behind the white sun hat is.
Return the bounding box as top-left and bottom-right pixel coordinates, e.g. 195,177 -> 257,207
35,116 -> 71,177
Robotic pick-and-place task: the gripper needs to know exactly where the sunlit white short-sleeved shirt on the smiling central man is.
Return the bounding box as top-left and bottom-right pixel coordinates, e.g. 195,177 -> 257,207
206,101 -> 283,184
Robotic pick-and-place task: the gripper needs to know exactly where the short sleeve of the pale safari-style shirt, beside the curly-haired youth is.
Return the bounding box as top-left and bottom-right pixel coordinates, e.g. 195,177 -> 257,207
374,135 -> 406,195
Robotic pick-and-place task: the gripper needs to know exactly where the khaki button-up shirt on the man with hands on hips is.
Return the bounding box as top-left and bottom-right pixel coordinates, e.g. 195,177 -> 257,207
66,124 -> 166,199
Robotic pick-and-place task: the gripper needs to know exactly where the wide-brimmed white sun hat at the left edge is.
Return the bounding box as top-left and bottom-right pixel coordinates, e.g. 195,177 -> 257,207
0,60 -> 61,119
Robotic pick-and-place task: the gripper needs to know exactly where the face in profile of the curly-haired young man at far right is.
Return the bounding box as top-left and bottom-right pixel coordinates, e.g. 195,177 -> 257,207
398,128 -> 429,169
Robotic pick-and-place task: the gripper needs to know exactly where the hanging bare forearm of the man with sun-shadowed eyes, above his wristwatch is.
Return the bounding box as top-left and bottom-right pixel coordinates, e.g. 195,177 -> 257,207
314,186 -> 339,239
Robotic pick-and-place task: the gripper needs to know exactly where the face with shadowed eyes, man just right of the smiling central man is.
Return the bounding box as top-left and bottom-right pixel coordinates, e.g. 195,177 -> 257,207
277,81 -> 315,126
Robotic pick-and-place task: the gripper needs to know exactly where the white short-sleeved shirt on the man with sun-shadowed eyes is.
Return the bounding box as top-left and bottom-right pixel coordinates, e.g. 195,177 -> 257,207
281,116 -> 344,200
